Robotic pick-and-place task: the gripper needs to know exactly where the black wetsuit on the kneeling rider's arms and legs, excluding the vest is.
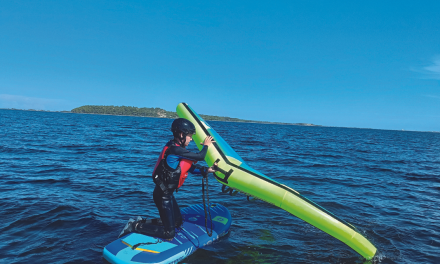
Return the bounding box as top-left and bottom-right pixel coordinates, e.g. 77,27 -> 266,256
135,140 -> 208,239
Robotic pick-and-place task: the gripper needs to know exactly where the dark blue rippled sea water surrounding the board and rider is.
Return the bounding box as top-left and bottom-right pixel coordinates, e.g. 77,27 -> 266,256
0,110 -> 440,263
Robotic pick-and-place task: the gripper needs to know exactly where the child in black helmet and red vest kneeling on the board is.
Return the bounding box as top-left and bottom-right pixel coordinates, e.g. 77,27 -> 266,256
119,118 -> 216,240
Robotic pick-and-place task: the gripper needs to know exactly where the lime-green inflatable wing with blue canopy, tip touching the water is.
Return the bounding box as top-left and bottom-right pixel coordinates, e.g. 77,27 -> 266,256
177,103 -> 377,260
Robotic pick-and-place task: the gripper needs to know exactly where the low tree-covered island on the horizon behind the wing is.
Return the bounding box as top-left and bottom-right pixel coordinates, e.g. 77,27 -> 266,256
70,105 -> 317,126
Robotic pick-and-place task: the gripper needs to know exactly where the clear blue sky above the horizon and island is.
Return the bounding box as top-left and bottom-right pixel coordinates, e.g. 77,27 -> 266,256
0,1 -> 440,131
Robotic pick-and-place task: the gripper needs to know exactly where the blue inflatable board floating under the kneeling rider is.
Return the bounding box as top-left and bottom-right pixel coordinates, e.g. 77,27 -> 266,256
103,203 -> 232,264
